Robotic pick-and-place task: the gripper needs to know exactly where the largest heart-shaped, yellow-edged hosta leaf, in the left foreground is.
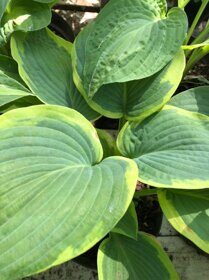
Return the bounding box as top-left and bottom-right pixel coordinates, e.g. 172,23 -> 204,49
0,105 -> 137,280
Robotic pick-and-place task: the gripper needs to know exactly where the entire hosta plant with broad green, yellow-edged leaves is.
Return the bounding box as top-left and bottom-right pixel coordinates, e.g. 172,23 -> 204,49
0,0 -> 209,280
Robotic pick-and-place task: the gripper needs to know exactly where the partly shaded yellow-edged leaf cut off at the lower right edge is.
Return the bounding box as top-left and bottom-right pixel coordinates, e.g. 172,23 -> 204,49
158,190 -> 209,253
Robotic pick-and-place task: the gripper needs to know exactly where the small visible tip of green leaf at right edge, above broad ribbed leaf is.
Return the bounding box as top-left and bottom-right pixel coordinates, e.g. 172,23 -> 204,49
169,86 -> 209,116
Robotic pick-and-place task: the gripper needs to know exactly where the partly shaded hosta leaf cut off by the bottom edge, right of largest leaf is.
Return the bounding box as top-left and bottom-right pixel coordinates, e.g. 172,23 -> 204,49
97,232 -> 179,280
